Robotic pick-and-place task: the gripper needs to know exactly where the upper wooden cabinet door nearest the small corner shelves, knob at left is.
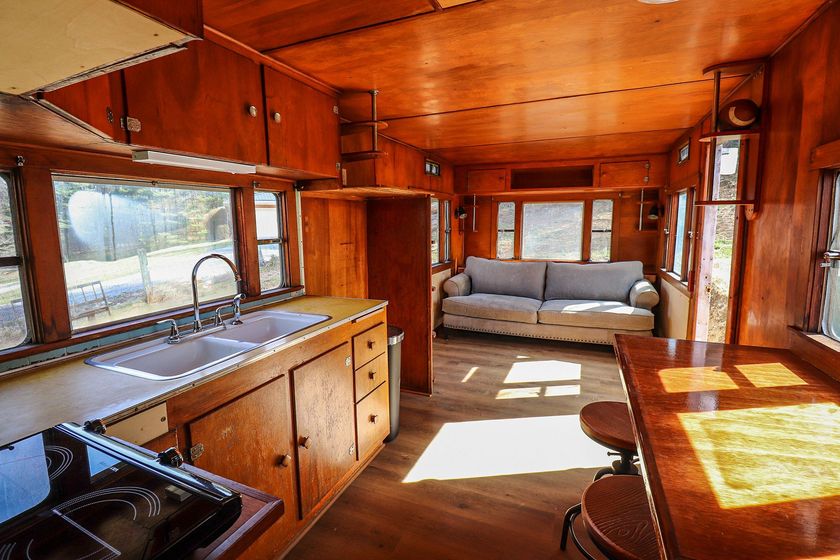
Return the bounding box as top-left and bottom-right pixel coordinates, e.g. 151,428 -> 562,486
263,67 -> 341,177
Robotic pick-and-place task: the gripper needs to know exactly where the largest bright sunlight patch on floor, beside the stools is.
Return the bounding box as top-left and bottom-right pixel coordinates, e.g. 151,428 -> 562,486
403,414 -> 610,483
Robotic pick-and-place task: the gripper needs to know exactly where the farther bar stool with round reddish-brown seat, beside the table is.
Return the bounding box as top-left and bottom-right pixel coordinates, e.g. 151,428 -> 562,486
580,401 -> 639,480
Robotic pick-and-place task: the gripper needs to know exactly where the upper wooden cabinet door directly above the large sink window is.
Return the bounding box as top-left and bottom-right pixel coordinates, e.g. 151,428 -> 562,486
124,41 -> 266,163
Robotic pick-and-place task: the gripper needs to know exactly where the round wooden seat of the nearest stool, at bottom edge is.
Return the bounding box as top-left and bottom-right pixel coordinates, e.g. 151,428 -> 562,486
581,475 -> 659,560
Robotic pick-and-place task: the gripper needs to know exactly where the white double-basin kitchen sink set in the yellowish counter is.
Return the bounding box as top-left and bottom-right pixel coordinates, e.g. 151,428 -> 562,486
86,311 -> 330,380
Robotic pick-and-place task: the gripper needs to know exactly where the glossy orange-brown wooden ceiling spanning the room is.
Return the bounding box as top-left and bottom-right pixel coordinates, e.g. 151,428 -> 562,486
204,0 -> 825,163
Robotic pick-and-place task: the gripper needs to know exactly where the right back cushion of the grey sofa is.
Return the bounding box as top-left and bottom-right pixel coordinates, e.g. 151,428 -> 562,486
545,261 -> 644,301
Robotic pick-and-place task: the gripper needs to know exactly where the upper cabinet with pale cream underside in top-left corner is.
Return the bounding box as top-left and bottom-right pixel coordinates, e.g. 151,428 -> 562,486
0,0 -> 203,95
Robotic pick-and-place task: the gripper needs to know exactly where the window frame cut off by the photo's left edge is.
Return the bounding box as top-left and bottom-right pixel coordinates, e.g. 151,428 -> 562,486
0,168 -> 31,350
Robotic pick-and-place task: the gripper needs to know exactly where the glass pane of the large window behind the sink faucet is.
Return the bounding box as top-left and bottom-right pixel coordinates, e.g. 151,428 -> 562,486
54,176 -> 236,330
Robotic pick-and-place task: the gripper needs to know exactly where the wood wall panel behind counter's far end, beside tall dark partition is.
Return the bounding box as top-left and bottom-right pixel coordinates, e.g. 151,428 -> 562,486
301,196 -> 368,298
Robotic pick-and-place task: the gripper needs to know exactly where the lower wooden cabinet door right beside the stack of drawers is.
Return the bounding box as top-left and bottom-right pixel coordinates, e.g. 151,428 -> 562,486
292,342 -> 356,517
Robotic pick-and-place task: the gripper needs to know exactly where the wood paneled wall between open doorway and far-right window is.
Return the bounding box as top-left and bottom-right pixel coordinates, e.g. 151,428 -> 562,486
738,4 -> 840,346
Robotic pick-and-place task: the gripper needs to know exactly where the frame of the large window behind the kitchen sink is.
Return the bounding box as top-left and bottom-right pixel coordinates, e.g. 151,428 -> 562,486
50,175 -> 241,332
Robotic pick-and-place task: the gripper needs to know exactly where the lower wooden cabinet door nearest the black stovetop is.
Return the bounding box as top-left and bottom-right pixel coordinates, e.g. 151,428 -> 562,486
187,376 -> 297,540
